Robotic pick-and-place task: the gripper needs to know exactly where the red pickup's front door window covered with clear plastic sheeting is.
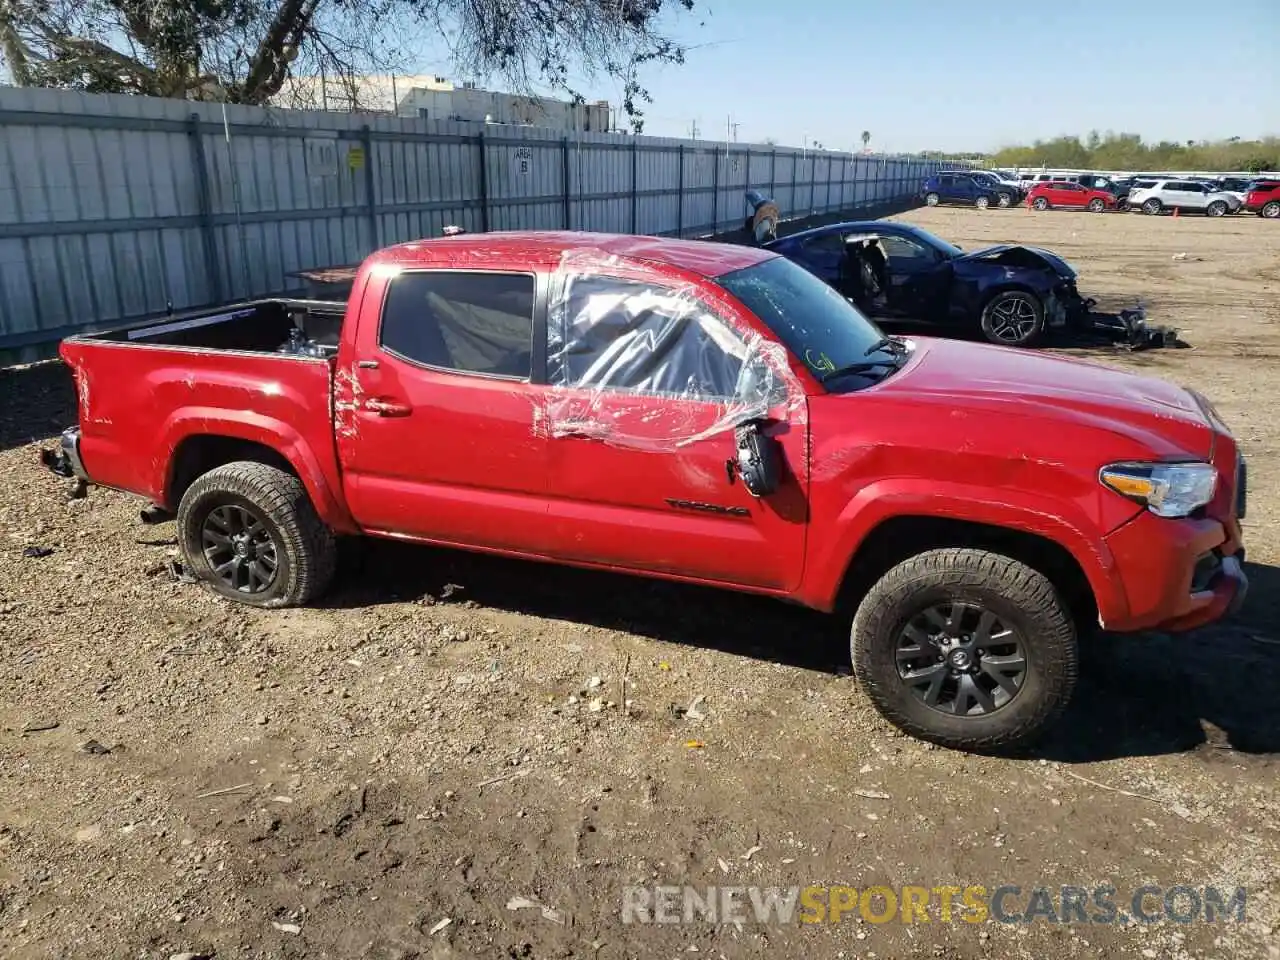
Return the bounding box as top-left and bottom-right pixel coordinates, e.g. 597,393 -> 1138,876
547,268 -> 762,402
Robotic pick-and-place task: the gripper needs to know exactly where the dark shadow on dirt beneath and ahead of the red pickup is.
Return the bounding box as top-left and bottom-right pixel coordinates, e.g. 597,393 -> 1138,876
330,541 -> 1280,763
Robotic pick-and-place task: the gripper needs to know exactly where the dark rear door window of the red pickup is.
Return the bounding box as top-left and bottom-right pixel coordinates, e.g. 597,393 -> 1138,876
379,270 -> 534,380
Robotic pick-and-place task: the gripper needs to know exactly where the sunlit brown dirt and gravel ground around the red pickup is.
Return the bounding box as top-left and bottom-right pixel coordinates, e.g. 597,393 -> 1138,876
0,204 -> 1280,960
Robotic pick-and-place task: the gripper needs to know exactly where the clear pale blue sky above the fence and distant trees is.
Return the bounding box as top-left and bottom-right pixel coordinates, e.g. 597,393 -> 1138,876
476,0 -> 1280,152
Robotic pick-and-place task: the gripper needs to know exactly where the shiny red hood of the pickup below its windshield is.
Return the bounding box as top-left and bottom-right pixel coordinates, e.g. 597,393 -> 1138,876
873,337 -> 1213,460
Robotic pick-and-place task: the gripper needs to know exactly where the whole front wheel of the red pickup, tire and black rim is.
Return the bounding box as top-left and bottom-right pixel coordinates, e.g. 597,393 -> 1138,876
850,549 -> 1079,750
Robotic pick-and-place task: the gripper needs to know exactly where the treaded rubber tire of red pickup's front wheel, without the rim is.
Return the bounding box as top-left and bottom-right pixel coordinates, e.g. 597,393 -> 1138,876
850,548 -> 1079,753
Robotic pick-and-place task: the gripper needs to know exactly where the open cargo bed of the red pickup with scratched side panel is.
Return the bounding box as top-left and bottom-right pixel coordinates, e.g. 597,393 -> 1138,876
60,300 -> 346,526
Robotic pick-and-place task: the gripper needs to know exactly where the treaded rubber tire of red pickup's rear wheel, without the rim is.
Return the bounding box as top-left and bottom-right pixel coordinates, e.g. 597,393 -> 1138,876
178,461 -> 338,607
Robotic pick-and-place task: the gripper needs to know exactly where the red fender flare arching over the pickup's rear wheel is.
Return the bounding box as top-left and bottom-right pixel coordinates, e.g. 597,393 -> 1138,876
155,407 -> 356,532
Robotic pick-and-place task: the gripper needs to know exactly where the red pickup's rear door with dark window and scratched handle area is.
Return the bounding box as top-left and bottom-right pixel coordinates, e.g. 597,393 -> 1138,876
334,270 -> 547,553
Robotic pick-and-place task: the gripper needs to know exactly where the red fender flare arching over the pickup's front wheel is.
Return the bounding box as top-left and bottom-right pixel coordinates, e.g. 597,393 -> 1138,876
800,477 -> 1129,622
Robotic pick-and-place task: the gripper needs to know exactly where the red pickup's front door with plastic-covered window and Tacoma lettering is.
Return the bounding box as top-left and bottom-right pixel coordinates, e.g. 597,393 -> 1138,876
547,274 -> 806,590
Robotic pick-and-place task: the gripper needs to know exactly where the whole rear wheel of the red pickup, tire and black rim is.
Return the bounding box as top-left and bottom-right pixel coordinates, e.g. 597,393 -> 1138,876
178,461 -> 337,607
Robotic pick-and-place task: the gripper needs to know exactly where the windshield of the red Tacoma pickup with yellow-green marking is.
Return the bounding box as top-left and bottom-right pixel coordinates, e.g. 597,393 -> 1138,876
716,257 -> 897,389
